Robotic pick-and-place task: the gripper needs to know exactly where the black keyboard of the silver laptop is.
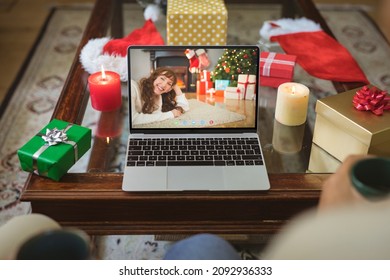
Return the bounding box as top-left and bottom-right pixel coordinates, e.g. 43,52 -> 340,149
127,138 -> 263,166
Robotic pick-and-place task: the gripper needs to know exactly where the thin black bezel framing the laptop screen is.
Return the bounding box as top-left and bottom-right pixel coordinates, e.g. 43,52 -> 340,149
127,45 -> 260,134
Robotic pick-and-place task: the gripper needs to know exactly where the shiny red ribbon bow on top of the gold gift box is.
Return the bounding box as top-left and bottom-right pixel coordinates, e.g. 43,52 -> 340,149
352,86 -> 390,116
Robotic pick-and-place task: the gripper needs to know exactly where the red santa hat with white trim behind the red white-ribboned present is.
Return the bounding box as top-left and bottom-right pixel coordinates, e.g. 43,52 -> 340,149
260,18 -> 369,84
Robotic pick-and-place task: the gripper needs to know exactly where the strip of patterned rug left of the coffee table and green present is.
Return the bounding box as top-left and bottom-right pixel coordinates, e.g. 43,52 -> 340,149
0,6 -> 90,219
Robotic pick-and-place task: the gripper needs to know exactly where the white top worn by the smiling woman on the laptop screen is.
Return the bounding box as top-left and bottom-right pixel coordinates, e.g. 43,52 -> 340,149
131,80 -> 190,125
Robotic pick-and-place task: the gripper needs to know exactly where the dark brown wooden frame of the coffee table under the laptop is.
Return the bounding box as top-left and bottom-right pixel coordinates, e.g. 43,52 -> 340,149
22,0 -> 361,234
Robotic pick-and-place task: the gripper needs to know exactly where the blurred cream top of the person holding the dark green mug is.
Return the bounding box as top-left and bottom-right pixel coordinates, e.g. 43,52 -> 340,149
263,199 -> 390,260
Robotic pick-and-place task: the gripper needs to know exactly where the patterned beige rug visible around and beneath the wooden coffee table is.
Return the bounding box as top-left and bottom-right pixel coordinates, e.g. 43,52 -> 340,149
0,2 -> 390,259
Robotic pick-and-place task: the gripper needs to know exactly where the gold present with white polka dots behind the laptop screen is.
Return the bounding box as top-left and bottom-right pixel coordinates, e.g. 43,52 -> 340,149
166,0 -> 228,45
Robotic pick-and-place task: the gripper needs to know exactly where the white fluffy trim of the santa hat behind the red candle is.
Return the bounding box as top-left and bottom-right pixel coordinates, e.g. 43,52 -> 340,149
80,37 -> 127,82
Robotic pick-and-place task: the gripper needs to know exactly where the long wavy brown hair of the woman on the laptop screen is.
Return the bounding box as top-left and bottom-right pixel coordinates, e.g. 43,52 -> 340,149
140,67 -> 183,114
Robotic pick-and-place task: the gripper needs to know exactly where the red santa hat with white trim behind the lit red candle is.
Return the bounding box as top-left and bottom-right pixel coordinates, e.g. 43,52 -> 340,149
80,18 -> 164,81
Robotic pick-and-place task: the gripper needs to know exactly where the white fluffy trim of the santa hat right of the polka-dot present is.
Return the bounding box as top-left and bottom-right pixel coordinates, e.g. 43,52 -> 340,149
260,17 -> 322,41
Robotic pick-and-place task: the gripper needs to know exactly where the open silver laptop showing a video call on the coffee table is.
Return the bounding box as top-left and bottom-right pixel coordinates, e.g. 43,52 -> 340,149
122,46 -> 270,192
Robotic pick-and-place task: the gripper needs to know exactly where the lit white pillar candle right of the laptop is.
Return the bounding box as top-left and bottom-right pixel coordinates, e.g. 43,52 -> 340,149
275,83 -> 310,126
